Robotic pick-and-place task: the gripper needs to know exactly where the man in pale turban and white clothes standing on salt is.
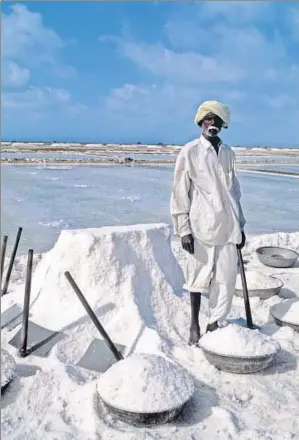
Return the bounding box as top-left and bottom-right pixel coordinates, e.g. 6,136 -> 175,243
170,101 -> 246,345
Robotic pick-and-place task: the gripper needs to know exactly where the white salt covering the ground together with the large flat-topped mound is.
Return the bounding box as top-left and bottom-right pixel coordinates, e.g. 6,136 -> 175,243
1,229 -> 299,440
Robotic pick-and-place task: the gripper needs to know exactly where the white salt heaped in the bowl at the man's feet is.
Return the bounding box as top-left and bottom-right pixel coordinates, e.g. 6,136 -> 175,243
199,324 -> 280,357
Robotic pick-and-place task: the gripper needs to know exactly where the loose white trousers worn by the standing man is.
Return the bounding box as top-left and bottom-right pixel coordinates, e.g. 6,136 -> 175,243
184,239 -> 237,324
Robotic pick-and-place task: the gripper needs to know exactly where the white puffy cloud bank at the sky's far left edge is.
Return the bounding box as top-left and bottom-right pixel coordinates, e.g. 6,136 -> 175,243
1,4 -> 82,130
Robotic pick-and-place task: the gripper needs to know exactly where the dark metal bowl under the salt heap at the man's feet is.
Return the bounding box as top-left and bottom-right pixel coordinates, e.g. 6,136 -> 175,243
202,348 -> 278,374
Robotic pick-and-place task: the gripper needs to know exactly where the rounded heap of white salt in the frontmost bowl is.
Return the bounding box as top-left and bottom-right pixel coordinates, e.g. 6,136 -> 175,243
97,353 -> 194,413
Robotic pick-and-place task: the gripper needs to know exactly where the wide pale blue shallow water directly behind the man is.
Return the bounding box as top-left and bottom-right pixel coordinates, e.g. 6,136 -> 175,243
1,165 -> 299,253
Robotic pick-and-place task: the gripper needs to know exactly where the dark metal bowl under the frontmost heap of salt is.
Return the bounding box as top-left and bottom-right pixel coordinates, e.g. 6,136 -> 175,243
101,399 -> 189,426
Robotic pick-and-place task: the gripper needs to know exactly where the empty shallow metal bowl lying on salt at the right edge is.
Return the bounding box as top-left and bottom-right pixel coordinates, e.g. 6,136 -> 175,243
256,246 -> 299,268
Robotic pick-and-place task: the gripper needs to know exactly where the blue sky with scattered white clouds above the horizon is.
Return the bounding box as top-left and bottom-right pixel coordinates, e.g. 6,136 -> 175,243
1,1 -> 299,146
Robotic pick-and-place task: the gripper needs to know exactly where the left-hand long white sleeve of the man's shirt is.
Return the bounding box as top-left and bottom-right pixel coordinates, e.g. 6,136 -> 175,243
170,150 -> 192,237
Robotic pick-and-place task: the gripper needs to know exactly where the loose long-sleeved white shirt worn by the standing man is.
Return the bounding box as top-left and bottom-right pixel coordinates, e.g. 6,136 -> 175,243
170,136 -> 245,245
